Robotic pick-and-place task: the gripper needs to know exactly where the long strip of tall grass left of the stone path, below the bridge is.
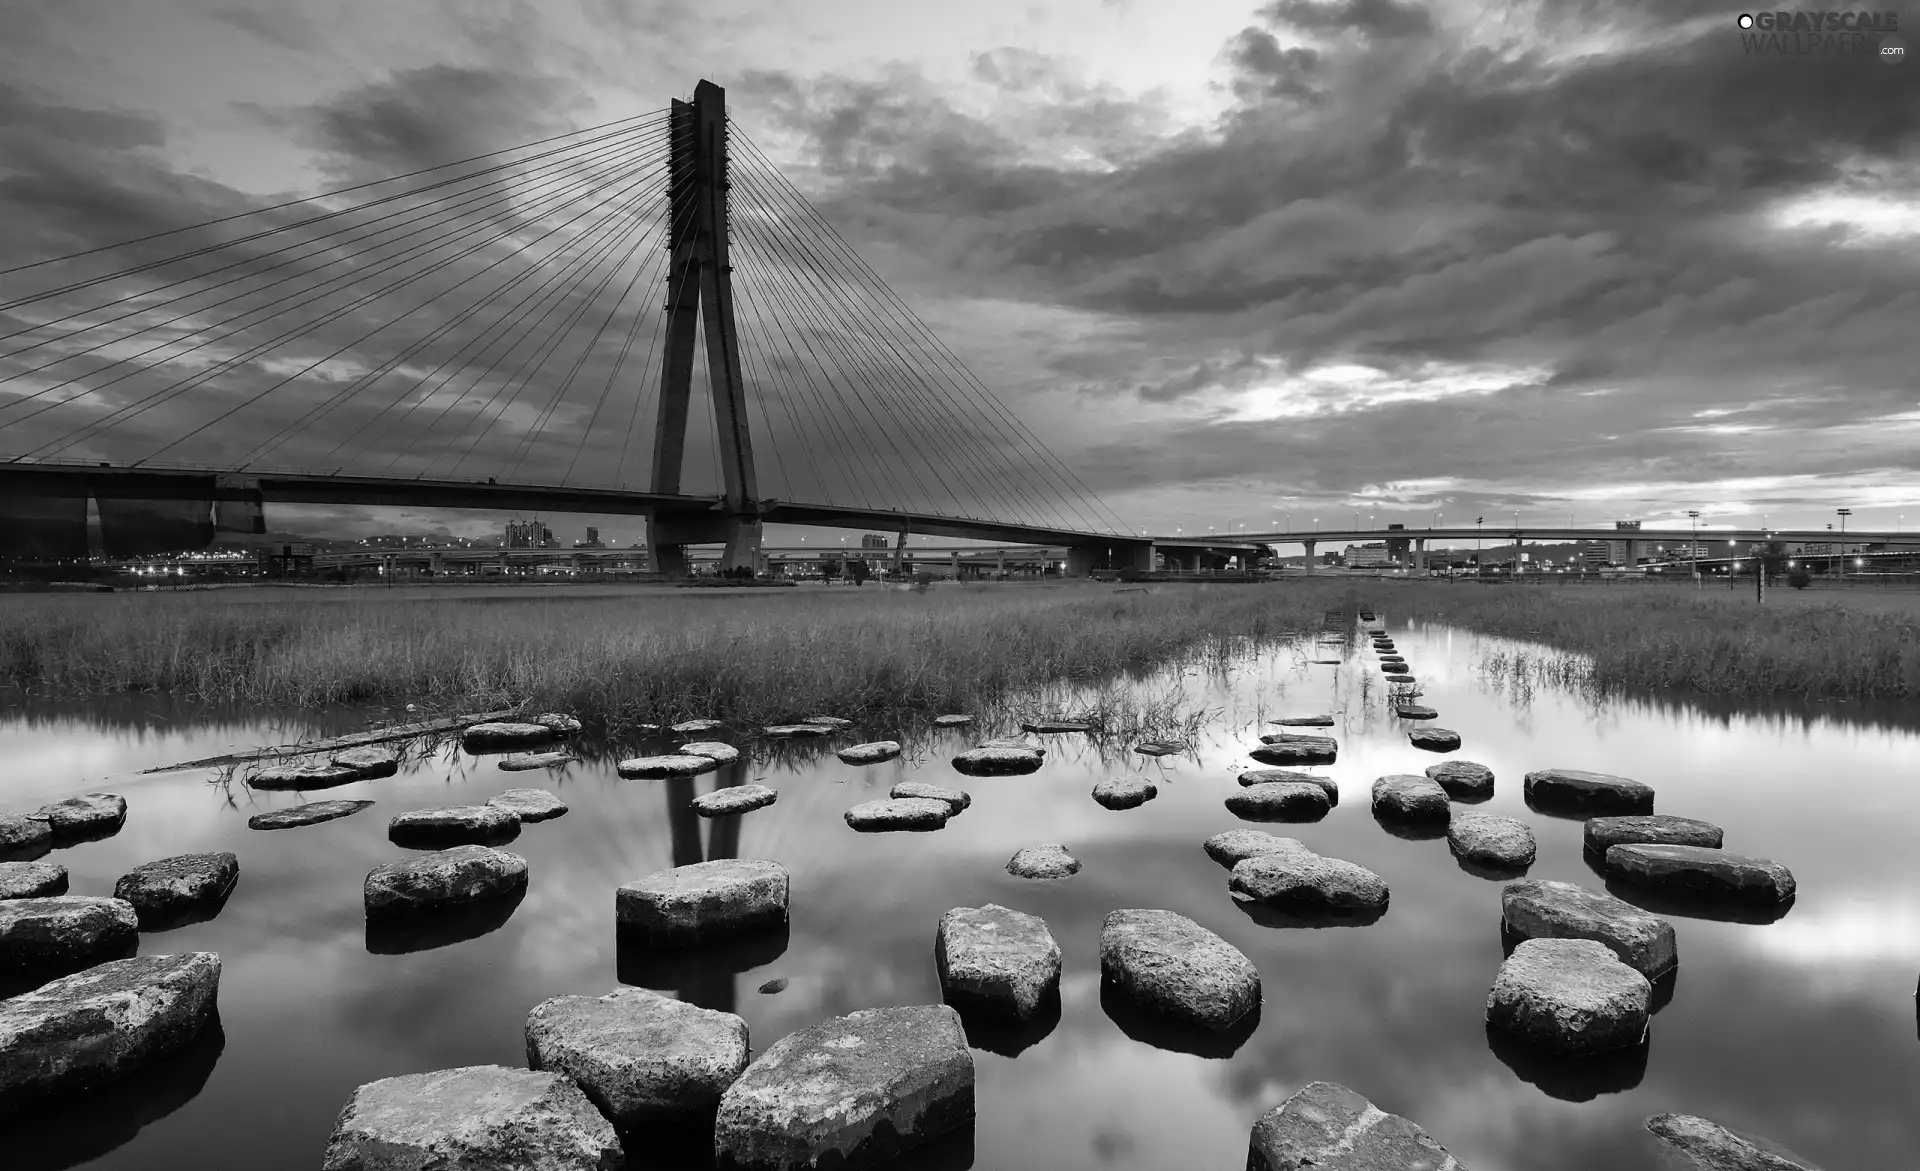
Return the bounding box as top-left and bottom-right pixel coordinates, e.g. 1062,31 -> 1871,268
0,584 -> 1348,731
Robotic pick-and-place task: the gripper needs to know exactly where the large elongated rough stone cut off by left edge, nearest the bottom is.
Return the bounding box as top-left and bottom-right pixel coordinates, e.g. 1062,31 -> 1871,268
0,952 -> 221,1105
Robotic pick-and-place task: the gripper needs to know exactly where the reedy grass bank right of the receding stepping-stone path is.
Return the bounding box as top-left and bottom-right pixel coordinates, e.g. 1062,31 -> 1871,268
1363,582 -> 1920,699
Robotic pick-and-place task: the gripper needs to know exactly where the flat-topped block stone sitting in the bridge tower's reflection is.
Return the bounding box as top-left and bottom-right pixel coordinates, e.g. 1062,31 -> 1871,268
614,858 -> 789,946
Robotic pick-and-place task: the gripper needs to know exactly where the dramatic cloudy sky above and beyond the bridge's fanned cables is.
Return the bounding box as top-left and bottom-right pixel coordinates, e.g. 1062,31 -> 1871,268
0,0 -> 1920,536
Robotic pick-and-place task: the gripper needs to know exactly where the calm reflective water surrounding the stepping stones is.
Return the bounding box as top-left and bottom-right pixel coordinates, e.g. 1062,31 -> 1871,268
0,620 -> 1920,1171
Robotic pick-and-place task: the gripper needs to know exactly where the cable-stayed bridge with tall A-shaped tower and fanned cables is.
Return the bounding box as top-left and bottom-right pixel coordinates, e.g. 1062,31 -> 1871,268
0,81 -> 1221,572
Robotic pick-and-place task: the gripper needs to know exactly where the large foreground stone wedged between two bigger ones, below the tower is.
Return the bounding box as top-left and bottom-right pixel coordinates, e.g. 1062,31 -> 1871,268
526,989 -> 749,1131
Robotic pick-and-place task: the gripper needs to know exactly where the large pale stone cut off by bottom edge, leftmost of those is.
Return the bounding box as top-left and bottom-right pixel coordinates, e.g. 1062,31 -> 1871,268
321,1065 -> 624,1171
